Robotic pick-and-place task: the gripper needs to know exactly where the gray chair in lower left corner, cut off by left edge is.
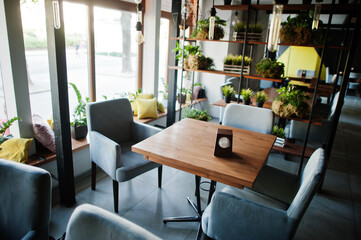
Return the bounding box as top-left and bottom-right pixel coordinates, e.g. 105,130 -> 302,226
0,159 -> 51,240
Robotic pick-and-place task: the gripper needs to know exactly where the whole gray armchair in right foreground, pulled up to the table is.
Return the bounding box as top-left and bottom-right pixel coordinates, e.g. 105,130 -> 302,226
202,149 -> 326,240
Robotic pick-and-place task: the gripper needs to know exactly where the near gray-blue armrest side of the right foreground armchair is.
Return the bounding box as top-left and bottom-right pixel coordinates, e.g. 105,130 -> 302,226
202,190 -> 290,239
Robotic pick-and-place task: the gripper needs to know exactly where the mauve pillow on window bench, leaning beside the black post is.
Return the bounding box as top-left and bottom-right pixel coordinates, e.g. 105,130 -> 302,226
33,114 -> 56,153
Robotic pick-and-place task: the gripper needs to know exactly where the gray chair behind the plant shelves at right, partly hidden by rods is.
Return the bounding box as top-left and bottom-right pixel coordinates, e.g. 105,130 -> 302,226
289,92 -> 339,145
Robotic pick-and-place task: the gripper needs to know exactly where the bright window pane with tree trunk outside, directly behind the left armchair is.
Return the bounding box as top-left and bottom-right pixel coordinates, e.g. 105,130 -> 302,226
94,7 -> 138,100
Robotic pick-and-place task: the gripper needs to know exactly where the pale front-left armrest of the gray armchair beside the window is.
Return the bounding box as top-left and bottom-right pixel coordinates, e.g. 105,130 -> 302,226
89,131 -> 121,179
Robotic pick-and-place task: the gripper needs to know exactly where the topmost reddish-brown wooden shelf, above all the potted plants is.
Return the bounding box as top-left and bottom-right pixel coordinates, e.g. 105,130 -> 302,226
214,4 -> 358,14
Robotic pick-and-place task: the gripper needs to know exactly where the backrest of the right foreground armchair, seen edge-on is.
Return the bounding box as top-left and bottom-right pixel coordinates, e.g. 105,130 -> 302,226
287,148 -> 326,222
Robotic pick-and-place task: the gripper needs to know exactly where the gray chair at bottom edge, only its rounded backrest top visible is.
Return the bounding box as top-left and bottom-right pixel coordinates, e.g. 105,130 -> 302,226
65,204 -> 160,240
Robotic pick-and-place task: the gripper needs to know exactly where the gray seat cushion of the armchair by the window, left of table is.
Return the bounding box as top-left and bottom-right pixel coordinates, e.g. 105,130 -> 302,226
116,141 -> 161,182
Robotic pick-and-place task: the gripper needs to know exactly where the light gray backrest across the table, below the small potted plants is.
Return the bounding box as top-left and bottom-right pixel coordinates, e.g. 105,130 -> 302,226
222,103 -> 273,134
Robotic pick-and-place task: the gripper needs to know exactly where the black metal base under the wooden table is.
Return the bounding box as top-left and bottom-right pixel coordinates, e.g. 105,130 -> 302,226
163,176 -> 216,223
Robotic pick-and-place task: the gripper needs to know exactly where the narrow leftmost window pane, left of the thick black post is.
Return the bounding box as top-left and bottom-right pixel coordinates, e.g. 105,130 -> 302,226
21,0 -> 52,119
